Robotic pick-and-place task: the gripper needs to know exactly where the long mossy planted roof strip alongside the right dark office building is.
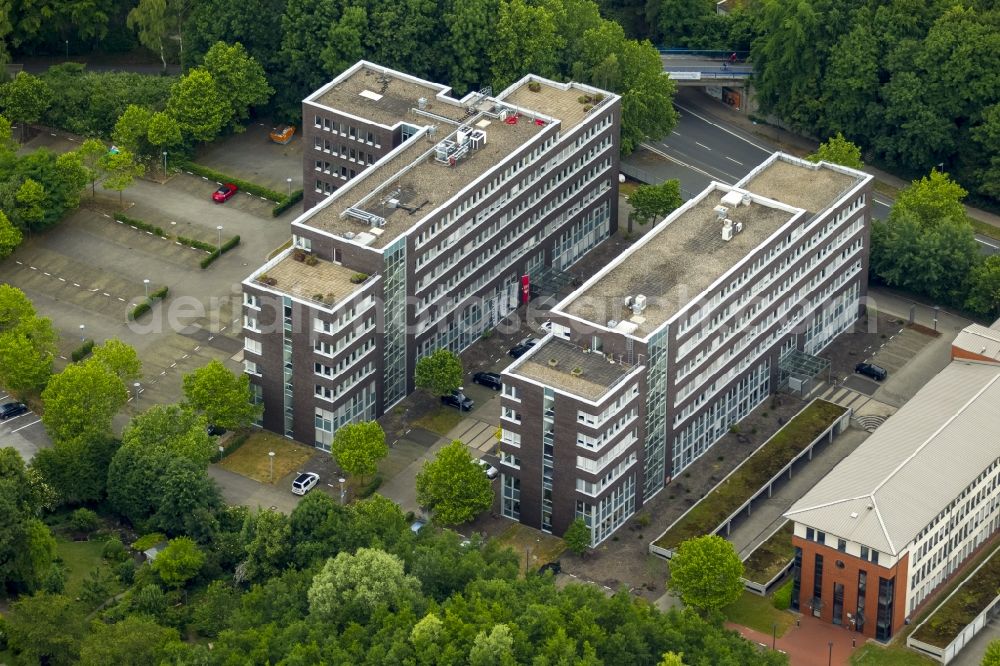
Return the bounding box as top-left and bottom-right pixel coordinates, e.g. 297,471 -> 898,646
656,400 -> 847,549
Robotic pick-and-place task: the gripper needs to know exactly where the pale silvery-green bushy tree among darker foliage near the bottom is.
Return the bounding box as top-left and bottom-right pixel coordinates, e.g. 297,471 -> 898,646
309,548 -> 420,621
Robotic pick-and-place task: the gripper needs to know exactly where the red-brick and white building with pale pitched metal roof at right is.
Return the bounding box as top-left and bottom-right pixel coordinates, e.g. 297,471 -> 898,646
785,361 -> 1000,640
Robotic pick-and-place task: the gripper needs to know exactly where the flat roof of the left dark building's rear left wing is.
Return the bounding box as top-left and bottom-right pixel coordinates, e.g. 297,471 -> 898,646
307,63 -> 466,127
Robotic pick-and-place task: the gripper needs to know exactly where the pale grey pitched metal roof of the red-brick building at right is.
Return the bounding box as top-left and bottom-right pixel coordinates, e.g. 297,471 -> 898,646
785,361 -> 1000,555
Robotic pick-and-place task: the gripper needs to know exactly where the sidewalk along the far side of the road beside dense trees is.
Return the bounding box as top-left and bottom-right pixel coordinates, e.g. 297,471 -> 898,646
677,88 -> 1000,227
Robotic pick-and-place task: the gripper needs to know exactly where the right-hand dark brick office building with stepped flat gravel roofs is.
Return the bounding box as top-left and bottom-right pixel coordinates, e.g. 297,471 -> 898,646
501,154 -> 871,544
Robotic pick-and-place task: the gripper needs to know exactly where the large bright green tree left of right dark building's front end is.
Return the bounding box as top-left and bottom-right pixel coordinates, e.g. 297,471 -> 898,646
417,439 -> 493,525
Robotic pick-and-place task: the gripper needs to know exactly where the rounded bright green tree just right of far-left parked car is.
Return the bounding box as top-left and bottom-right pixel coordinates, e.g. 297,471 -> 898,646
42,361 -> 128,442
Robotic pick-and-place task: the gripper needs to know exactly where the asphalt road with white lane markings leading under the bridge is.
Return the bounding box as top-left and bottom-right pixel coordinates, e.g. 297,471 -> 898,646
644,104 -> 1000,254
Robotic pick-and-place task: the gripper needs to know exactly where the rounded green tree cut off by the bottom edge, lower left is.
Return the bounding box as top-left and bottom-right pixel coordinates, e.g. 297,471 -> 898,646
78,612 -> 181,666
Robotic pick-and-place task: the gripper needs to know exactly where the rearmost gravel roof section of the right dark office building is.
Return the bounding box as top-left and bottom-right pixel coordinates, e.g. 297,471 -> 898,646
736,155 -> 861,214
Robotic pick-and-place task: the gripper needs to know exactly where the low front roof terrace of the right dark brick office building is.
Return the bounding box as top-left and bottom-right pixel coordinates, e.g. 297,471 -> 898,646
512,336 -> 635,400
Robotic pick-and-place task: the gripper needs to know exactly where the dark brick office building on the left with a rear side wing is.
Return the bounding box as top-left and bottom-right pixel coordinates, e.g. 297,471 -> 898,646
244,62 -> 621,448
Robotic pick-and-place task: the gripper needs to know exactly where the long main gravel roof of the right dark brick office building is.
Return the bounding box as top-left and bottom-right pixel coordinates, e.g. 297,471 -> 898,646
556,186 -> 797,337
